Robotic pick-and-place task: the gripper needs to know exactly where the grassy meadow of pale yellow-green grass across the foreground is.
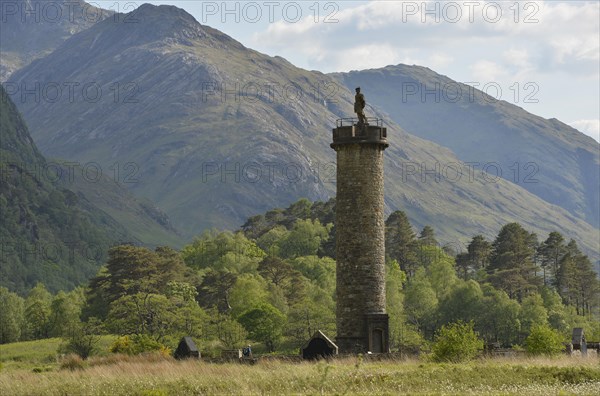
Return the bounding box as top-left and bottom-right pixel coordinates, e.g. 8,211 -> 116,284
0,338 -> 600,396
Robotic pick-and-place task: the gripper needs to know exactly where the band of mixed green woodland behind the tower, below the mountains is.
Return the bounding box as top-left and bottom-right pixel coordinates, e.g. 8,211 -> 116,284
0,199 -> 600,352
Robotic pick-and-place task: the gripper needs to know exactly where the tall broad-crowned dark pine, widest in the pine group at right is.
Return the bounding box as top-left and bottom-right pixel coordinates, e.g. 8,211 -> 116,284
487,223 -> 541,299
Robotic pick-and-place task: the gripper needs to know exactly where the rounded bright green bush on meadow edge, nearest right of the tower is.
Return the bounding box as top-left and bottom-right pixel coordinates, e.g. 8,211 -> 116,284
431,321 -> 483,362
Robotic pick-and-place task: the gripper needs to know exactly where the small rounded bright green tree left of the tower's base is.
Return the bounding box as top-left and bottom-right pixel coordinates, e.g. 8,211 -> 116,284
238,303 -> 285,352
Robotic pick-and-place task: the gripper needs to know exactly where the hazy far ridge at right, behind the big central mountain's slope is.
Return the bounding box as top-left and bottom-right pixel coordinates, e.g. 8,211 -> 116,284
332,65 -> 600,227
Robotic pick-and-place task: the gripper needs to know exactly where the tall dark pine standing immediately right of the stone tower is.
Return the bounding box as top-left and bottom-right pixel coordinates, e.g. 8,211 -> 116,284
385,211 -> 417,278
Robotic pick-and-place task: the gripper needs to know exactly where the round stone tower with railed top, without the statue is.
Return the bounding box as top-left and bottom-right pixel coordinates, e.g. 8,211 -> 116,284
331,118 -> 389,353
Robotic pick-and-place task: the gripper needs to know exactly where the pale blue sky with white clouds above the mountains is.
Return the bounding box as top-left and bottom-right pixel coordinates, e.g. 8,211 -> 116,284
92,0 -> 600,141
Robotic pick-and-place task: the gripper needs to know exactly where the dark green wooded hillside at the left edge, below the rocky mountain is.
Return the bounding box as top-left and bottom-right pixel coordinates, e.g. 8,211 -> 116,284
0,86 -> 183,292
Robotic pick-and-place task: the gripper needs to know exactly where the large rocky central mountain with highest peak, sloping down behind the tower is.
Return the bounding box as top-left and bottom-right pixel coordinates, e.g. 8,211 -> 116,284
9,4 -> 598,260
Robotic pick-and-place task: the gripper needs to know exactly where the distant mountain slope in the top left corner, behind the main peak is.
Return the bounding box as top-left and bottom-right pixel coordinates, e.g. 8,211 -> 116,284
0,0 -> 112,81
